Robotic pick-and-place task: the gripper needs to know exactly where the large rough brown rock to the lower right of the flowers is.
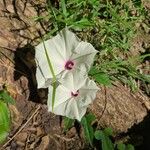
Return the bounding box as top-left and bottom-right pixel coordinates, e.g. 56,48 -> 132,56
90,83 -> 150,134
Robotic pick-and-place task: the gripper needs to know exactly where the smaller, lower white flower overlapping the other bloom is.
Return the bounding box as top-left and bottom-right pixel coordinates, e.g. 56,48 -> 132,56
47,71 -> 99,121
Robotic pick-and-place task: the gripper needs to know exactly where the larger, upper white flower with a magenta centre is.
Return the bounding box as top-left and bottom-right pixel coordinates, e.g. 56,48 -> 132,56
35,28 -> 97,88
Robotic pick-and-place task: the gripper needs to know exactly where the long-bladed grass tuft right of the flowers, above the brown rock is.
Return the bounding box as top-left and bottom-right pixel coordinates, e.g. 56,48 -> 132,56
93,54 -> 150,91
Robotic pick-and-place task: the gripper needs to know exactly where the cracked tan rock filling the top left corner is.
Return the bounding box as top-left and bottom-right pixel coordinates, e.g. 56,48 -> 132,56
0,0 -> 46,51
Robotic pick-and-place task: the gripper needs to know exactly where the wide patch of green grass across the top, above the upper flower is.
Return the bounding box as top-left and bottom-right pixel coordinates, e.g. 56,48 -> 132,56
38,0 -> 142,52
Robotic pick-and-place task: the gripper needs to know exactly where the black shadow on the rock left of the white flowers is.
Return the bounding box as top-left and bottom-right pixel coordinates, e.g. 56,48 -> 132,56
14,44 -> 48,103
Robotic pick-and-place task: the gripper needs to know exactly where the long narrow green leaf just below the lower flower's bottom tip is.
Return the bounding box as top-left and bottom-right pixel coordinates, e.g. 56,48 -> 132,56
81,114 -> 95,146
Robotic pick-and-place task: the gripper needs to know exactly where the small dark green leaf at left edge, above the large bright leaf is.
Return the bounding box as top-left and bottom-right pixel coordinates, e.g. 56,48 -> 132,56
0,90 -> 15,104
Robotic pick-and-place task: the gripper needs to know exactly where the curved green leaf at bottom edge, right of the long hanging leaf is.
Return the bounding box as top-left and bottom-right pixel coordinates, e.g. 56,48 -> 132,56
94,130 -> 114,150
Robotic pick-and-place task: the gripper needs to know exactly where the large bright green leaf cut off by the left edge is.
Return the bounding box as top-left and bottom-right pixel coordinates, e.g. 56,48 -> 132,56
0,100 -> 10,143
